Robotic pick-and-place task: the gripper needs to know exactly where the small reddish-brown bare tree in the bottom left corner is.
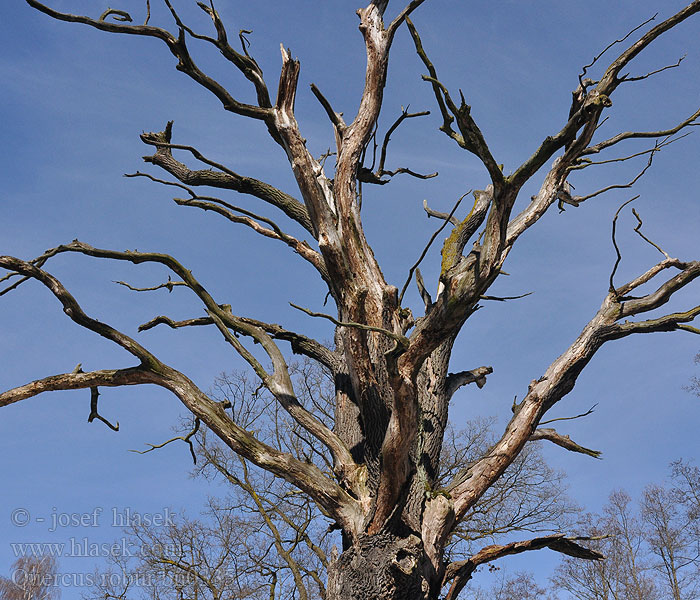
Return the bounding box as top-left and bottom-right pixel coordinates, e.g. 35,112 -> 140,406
0,556 -> 61,600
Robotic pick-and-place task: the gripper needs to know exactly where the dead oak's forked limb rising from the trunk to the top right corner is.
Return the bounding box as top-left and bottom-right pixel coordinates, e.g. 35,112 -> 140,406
402,0 -> 700,380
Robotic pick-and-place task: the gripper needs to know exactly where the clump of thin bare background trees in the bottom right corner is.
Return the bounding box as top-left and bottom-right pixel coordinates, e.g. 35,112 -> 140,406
553,461 -> 700,600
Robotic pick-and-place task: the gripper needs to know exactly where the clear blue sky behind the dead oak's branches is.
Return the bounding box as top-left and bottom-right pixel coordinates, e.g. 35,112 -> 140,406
0,0 -> 700,600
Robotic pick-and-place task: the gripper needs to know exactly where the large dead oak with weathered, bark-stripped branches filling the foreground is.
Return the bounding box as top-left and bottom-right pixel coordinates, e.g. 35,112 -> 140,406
0,0 -> 700,600
